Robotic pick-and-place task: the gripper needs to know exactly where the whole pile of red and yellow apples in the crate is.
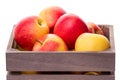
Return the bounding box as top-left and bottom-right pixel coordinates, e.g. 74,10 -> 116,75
14,6 -> 110,51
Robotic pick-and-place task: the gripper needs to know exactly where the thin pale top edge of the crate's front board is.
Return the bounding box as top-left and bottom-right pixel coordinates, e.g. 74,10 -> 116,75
6,49 -> 115,54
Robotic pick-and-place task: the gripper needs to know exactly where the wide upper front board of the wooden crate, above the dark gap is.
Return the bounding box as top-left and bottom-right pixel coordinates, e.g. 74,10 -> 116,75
7,52 -> 114,71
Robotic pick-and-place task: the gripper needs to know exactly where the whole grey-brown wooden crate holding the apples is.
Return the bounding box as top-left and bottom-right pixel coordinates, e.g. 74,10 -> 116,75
6,25 -> 115,80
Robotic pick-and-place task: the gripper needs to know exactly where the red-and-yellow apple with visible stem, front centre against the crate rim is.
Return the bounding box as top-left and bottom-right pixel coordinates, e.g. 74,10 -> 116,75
32,34 -> 68,51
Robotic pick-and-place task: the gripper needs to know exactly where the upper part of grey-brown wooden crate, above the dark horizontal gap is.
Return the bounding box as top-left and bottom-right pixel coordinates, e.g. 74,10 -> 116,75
6,25 -> 115,71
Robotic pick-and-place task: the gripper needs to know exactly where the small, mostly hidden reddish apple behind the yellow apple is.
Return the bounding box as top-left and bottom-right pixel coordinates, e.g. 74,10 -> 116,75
86,22 -> 104,35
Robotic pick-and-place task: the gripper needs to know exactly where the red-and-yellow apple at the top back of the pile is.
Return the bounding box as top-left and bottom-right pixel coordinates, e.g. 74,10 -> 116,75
39,6 -> 66,32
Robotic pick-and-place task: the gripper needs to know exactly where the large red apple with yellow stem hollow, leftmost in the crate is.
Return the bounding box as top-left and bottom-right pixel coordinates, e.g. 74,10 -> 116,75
14,16 -> 49,50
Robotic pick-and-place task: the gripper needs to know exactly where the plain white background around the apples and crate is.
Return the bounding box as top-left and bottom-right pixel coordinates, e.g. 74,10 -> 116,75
0,0 -> 120,80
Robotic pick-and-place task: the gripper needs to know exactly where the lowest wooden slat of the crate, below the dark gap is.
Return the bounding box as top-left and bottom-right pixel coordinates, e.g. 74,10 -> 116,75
7,74 -> 115,80
